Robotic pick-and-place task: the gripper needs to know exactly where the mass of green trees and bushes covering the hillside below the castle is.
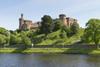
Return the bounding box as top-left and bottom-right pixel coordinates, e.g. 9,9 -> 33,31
0,15 -> 80,47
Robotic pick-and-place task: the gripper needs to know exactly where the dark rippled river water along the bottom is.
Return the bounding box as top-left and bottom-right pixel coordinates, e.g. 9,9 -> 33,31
0,53 -> 100,67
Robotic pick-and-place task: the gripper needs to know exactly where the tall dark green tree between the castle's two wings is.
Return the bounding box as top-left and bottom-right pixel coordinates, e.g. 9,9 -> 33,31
40,15 -> 52,35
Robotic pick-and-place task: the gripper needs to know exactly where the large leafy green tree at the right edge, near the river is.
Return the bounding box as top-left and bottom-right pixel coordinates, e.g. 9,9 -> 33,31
83,19 -> 100,48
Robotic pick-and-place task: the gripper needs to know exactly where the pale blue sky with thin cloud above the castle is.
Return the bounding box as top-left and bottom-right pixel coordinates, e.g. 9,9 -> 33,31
0,0 -> 100,30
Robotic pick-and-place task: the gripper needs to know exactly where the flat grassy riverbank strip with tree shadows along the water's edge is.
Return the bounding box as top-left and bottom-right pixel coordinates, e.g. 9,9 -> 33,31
0,48 -> 100,55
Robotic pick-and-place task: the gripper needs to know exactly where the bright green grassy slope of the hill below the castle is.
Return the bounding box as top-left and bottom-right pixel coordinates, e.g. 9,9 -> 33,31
35,30 -> 84,45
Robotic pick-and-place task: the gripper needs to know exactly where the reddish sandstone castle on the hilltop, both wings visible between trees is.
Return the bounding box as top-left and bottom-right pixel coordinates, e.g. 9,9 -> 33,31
19,14 -> 77,30
